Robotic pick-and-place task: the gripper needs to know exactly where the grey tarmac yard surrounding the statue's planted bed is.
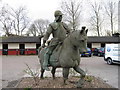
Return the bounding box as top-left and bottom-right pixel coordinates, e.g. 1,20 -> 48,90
0,55 -> 119,88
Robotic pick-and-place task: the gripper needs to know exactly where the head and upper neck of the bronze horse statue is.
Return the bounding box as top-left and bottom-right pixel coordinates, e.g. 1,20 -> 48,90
70,29 -> 88,53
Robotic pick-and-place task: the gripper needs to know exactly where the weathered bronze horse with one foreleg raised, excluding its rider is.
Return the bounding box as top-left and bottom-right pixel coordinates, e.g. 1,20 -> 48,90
38,30 -> 88,88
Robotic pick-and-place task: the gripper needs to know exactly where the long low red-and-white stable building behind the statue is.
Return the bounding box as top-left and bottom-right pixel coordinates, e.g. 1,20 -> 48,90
0,36 -> 120,55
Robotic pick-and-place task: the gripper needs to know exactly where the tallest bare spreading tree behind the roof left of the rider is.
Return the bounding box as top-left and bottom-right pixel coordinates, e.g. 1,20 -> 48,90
8,7 -> 29,35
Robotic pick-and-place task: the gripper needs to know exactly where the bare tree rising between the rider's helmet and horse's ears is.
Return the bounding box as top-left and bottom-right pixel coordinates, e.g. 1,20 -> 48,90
61,0 -> 82,31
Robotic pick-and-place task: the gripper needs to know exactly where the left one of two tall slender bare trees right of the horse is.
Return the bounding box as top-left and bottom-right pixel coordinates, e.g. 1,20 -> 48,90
90,2 -> 103,36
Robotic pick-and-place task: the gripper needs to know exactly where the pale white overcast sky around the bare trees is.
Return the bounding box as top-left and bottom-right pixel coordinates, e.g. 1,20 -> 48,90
0,0 -> 119,35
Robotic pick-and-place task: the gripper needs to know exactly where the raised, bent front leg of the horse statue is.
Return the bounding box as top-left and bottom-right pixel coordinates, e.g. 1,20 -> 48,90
73,66 -> 86,88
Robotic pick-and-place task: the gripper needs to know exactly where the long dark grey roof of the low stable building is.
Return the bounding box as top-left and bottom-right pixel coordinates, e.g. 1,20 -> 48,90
1,36 -> 120,43
